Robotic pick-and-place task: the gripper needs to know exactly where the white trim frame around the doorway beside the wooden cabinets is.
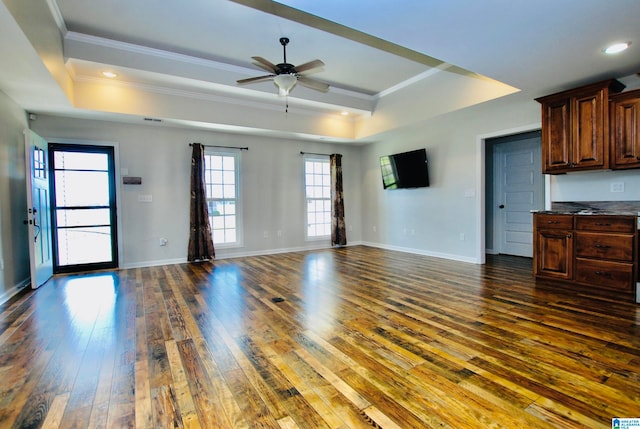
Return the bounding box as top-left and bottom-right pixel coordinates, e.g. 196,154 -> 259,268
476,122 -> 551,264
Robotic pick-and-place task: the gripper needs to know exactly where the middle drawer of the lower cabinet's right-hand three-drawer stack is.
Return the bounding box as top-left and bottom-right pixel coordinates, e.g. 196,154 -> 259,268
575,231 -> 634,262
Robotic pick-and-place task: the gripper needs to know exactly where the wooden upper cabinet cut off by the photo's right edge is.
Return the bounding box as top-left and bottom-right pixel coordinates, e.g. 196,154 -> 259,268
609,89 -> 640,168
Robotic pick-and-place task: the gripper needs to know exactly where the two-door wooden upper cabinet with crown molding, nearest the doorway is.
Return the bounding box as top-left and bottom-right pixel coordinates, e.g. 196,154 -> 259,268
536,79 -> 624,174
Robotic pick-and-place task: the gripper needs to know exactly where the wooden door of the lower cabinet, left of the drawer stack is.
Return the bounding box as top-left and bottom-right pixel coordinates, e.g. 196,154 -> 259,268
534,229 -> 573,280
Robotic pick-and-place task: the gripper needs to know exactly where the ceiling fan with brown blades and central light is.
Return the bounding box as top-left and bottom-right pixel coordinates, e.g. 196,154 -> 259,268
237,37 -> 329,95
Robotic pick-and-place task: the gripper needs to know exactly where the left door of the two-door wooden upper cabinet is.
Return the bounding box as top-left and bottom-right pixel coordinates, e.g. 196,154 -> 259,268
542,97 -> 571,173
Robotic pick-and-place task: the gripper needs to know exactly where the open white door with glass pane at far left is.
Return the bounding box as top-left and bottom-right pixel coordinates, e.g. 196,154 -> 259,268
24,130 -> 53,289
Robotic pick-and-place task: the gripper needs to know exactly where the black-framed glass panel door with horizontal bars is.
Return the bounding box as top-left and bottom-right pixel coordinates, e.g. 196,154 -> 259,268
49,144 -> 118,273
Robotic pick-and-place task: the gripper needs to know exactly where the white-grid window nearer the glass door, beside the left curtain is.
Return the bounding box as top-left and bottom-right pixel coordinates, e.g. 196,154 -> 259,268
204,148 -> 241,246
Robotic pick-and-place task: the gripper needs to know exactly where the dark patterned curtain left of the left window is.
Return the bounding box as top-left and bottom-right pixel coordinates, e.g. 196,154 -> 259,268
187,143 -> 216,261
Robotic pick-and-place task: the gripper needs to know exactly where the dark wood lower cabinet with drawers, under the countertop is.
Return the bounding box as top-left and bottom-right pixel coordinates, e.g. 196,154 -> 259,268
533,213 -> 638,293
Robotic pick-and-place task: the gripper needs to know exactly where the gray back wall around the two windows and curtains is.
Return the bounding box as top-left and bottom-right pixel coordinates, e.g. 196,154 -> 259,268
32,115 -> 362,267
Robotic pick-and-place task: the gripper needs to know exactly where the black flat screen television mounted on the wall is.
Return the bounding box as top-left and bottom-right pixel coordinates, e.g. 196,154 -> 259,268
380,149 -> 429,189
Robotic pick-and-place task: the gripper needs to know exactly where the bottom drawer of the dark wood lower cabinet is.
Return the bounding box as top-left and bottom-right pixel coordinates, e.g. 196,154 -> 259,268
575,258 -> 633,291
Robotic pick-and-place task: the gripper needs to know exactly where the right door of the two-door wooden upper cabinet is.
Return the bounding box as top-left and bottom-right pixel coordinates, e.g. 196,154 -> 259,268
571,89 -> 609,169
